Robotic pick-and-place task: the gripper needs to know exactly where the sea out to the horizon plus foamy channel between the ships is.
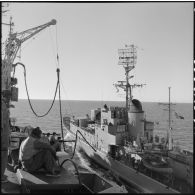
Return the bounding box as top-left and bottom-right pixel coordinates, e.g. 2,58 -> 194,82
10,100 -> 193,193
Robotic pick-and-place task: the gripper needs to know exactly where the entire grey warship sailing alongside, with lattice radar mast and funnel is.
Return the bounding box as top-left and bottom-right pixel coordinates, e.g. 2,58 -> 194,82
63,45 -> 193,193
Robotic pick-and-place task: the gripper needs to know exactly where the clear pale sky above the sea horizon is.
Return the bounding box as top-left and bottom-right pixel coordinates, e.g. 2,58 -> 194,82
2,2 -> 194,103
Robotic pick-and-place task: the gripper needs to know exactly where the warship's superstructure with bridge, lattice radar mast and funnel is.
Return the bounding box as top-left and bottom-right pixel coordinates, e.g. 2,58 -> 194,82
65,45 -> 154,152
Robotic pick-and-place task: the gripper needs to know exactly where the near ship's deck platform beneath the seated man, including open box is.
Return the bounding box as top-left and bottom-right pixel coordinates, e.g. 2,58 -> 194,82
1,151 -> 126,194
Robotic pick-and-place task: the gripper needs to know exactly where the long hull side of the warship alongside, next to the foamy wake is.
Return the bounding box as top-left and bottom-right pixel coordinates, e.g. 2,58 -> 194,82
64,123 -> 177,193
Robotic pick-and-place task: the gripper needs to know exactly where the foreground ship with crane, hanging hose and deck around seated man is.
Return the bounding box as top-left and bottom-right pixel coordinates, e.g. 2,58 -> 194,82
1,12 -> 127,194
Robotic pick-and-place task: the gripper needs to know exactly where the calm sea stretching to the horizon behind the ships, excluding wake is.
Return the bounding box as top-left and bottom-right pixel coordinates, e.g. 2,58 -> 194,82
10,100 -> 193,151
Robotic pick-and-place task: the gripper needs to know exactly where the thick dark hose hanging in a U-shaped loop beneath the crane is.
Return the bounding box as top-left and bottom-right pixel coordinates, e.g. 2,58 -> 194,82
13,62 -> 59,117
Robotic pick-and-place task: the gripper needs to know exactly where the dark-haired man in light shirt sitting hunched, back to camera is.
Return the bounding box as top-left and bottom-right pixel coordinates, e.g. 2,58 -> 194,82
19,127 -> 60,175
